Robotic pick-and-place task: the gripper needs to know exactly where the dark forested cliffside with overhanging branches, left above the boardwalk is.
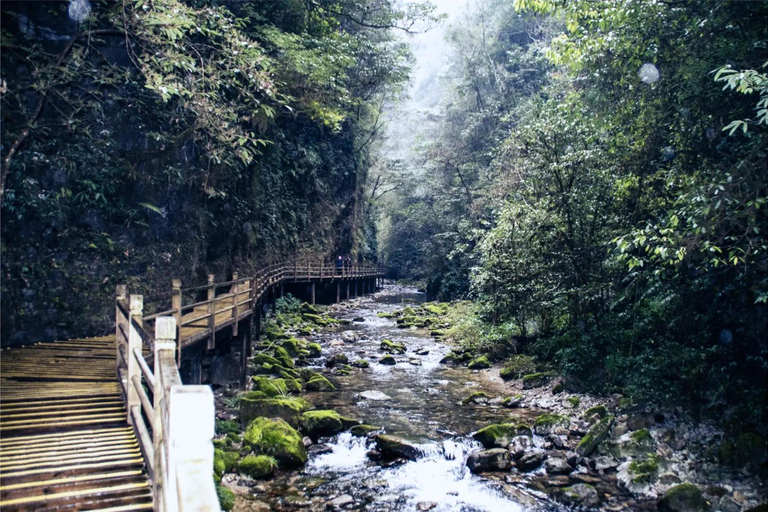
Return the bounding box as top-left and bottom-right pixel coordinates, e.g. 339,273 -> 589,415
0,0 -> 437,345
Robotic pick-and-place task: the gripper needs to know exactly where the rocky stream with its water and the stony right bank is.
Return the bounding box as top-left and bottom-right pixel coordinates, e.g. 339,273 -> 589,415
212,285 -> 766,512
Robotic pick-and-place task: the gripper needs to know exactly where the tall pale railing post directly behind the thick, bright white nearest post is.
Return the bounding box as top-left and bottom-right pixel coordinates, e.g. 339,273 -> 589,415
152,316 -> 176,510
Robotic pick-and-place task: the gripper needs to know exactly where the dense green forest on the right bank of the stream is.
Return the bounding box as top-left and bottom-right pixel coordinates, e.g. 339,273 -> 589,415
377,0 -> 768,427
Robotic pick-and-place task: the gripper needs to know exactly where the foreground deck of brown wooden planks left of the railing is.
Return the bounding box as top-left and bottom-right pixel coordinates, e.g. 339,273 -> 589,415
0,336 -> 152,512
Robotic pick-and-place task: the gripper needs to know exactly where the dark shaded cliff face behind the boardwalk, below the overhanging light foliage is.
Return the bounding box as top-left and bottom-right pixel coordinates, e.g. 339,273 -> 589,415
2,2 -> 384,346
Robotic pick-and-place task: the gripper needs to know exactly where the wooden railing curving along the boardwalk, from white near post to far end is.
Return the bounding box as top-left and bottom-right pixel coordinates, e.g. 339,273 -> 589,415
115,262 -> 384,511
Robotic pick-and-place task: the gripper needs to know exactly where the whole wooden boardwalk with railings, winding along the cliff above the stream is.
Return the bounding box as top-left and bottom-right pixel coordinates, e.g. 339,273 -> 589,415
0,262 -> 383,512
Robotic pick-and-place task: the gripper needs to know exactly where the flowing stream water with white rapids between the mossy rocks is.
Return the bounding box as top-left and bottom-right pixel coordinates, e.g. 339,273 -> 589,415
260,287 -> 552,512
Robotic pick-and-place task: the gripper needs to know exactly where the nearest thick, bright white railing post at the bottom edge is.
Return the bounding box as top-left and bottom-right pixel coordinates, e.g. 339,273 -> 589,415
168,385 -> 219,511
